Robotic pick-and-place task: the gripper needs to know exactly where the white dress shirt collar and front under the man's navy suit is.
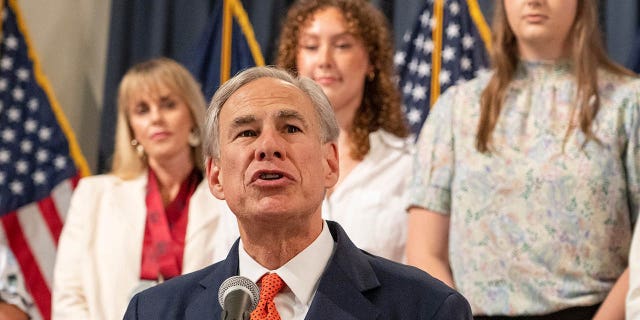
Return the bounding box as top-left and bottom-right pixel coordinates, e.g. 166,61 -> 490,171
238,222 -> 335,320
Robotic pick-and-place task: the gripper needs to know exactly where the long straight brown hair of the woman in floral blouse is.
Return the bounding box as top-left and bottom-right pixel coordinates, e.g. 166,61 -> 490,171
476,0 -> 633,153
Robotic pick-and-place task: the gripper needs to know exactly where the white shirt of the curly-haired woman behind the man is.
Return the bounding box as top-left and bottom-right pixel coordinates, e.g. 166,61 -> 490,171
322,130 -> 413,263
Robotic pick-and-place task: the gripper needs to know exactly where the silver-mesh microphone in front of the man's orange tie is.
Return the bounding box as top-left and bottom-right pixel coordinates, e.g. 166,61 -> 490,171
218,276 -> 260,320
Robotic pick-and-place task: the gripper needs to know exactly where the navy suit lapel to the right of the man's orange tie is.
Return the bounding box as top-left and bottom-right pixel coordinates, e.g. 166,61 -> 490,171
306,221 -> 380,320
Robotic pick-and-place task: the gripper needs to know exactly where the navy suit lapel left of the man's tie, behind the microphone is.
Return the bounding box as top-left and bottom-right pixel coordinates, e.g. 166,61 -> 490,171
185,241 -> 239,320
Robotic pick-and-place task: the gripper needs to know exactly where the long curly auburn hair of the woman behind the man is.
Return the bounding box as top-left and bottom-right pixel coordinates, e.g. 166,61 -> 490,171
276,0 -> 409,160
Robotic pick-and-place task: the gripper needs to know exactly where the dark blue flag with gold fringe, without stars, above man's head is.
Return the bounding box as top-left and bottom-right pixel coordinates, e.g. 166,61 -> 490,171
185,0 -> 264,101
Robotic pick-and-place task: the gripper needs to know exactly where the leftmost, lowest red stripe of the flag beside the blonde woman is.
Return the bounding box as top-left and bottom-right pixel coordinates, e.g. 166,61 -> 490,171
2,211 -> 51,318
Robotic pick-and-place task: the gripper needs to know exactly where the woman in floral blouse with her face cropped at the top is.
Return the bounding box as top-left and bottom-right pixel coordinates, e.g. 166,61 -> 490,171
407,0 -> 640,319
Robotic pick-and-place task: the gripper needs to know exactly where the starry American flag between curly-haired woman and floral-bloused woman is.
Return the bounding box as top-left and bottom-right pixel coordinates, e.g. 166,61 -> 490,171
394,0 -> 490,137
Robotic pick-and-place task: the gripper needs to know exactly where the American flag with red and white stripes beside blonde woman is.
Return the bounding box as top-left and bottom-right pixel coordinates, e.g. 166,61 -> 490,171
0,0 -> 89,319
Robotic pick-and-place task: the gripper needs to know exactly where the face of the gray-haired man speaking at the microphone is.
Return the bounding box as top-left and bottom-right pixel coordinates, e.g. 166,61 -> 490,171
207,78 -> 338,222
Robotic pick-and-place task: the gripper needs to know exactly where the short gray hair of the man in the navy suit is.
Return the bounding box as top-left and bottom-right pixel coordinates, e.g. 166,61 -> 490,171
203,66 -> 340,159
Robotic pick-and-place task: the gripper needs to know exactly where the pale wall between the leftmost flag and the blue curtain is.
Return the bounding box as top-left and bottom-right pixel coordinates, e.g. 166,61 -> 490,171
18,0 -> 111,172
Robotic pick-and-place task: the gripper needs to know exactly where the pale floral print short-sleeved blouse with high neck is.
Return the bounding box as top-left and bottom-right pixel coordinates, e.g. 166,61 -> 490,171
411,62 -> 640,315
